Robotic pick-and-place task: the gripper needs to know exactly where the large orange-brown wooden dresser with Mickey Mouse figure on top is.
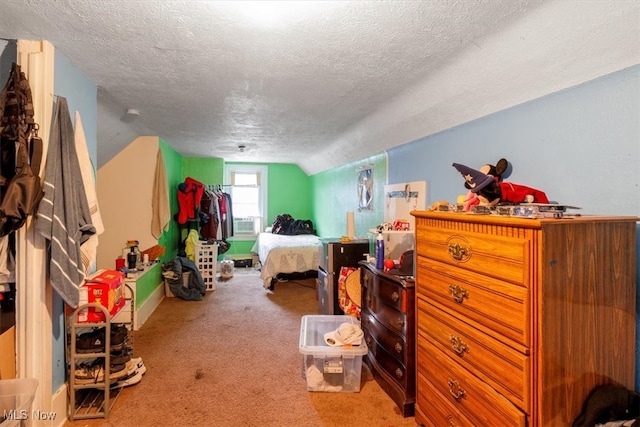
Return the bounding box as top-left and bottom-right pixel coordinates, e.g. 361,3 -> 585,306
412,211 -> 638,427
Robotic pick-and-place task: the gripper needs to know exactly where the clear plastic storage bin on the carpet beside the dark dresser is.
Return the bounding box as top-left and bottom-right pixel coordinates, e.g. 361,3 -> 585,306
299,315 -> 368,393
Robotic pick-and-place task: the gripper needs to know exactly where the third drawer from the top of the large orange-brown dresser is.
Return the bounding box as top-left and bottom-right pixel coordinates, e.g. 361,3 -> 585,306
418,299 -> 530,410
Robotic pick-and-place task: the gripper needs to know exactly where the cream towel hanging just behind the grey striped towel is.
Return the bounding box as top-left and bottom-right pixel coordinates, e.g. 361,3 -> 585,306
74,111 -> 104,275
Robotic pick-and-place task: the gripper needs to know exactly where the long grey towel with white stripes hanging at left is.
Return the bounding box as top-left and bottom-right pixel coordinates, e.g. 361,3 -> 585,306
35,97 -> 96,308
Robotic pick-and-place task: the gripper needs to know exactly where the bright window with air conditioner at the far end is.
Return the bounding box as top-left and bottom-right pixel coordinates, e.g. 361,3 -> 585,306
225,165 -> 267,240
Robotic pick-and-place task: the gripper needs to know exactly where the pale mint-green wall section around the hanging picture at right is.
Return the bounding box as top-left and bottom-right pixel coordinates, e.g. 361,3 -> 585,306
308,153 -> 387,238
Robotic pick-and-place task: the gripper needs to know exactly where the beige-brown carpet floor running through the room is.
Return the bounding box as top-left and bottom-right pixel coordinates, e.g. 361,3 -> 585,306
65,269 -> 416,427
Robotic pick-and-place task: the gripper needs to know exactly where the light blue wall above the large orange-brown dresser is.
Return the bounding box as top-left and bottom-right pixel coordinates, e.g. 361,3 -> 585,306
388,66 -> 640,390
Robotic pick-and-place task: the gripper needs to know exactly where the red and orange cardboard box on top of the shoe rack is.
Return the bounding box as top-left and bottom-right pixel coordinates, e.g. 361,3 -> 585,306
72,270 -> 126,323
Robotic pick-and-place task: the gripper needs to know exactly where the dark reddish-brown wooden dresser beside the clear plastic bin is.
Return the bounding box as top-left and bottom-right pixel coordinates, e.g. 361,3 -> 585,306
360,262 -> 416,417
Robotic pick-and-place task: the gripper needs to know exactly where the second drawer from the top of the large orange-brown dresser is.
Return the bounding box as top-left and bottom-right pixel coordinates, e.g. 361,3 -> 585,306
416,256 -> 530,353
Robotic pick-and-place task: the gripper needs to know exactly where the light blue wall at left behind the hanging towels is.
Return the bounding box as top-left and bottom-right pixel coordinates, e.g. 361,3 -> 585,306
52,52 -> 98,392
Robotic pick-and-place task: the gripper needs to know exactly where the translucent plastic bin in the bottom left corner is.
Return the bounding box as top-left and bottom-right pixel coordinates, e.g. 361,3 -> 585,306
0,378 -> 38,427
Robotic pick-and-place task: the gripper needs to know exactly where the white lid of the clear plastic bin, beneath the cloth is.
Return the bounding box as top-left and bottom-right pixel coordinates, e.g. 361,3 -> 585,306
298,315 -> 368,357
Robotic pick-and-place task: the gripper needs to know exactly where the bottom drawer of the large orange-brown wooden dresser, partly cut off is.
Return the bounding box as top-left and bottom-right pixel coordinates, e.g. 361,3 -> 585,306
416,373 -> 476,427
